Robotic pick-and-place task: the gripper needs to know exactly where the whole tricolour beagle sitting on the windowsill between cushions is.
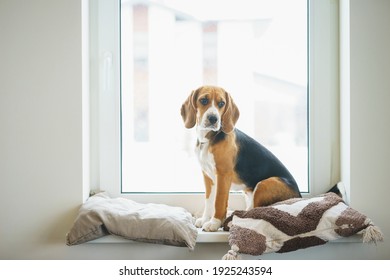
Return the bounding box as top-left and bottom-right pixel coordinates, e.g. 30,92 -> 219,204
181,86 -> 301,231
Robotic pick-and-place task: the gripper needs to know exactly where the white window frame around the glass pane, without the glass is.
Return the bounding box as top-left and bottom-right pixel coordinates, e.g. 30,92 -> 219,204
89,0 -> 340,217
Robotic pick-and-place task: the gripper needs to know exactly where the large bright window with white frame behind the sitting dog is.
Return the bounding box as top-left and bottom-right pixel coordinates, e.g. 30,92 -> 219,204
90,0 -> 339,211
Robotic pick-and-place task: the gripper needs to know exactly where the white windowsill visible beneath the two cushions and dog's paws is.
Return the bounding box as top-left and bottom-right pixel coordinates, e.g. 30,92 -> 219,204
88,229 -> 362,244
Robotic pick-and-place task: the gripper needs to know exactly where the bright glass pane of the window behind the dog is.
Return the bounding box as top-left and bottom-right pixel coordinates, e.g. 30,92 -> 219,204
121,0 -> 308,192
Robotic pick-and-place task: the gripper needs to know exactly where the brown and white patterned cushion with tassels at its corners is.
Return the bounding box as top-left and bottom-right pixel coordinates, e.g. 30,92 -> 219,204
224,193 -> 383,259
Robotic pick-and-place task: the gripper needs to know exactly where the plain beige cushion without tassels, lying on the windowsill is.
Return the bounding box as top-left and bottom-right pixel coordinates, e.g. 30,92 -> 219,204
66,193 -> 198,250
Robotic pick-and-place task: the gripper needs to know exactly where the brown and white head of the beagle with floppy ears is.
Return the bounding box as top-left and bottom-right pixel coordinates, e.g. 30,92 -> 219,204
181,86 -> 240,133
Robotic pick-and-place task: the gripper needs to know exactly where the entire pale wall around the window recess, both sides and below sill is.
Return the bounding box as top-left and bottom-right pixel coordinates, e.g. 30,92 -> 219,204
0,0 -> 390,259
